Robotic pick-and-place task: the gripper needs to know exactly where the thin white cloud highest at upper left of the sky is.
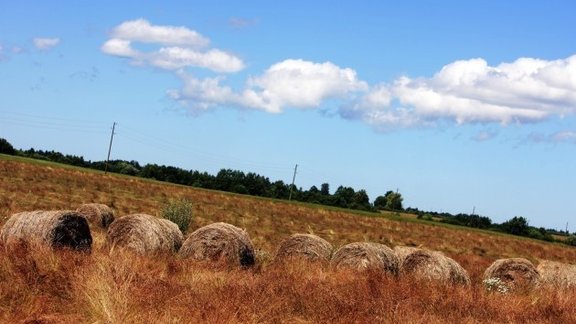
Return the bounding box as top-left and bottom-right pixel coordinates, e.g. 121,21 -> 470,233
100,19 -> 244,73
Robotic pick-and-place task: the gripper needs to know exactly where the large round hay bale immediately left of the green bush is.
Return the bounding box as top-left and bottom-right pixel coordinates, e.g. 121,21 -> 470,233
106,214 -> 184,255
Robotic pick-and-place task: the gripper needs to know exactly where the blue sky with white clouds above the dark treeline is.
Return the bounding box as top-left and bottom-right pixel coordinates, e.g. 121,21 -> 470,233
0,0 -> 576,231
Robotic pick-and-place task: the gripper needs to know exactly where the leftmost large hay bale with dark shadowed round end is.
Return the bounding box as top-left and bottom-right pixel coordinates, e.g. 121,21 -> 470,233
0,210 -> 92,251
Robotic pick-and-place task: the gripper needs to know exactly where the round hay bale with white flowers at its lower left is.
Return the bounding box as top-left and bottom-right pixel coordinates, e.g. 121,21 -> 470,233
484,258 -> 540,290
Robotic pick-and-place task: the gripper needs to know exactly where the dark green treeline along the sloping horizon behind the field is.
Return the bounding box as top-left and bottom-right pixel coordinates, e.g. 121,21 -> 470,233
0,138 -> 576,246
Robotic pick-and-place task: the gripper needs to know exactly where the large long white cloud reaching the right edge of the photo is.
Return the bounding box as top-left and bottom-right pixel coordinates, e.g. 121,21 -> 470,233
341,56 -> 576,128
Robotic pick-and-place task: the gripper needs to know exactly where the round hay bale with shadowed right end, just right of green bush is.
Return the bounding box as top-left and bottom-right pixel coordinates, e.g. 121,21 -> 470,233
180,222 -> 255,267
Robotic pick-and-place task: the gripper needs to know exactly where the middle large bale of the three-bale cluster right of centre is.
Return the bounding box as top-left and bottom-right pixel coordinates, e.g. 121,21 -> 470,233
331,242 -> 398,275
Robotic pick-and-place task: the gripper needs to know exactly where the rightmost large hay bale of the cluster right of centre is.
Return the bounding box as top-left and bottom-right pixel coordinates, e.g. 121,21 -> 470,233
400,249 -> 470,285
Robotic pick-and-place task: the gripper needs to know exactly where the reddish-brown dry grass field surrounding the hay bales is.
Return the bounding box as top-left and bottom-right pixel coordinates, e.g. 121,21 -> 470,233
0,155 -> 576,323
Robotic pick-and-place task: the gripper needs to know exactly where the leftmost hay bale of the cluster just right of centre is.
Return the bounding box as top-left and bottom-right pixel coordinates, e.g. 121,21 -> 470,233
275,234 -> 333,261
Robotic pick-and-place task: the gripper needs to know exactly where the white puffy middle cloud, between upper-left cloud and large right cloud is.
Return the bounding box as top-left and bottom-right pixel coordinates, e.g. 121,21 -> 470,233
170,59 -> 368,113
